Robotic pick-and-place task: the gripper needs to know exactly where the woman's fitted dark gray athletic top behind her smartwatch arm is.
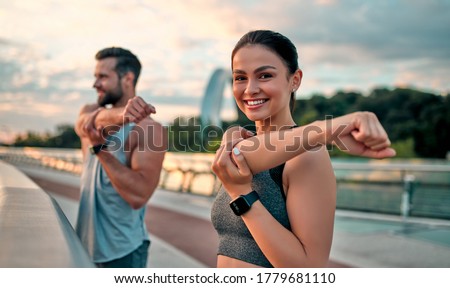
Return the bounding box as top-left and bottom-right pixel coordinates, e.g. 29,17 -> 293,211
211,164 -> 291,267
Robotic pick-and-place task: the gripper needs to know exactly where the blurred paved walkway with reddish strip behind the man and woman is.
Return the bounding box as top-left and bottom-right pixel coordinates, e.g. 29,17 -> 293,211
18,167 -> 450,268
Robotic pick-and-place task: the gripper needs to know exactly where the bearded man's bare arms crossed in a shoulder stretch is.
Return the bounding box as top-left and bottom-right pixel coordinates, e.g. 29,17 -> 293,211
76,97 -> 167,209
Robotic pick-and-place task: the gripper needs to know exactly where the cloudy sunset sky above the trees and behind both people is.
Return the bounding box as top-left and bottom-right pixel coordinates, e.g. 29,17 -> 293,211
0,0 -> 450,142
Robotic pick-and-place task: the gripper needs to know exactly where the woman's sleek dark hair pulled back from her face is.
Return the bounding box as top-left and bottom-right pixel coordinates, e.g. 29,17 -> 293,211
231,30 -> 298,112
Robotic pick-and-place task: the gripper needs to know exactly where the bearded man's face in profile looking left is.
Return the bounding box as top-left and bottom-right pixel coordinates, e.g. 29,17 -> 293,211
93,57 -> 123,107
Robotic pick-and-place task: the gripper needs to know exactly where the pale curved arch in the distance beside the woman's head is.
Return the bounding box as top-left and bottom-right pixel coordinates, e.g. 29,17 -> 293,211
200,68 -> 231,127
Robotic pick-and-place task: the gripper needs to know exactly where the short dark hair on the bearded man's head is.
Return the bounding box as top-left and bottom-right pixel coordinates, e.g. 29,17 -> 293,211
95,47 -> 142,86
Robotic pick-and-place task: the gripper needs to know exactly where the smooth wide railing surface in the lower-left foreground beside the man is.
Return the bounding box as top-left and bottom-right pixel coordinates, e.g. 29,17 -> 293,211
0,161 -> 95,268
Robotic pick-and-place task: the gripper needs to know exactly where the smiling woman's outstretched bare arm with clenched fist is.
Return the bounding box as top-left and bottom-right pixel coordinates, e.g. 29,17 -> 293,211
230,112 -> 395,174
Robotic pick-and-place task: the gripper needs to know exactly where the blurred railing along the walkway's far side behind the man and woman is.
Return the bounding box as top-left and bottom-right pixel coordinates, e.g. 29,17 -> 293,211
0,147 -> 450,219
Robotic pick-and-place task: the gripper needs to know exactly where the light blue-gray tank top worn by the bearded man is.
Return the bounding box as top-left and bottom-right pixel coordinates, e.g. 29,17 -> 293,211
76,123 -> 149,263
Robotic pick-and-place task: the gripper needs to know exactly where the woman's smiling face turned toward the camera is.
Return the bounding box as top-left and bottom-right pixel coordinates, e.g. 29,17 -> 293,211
232,45 -> 295,124
